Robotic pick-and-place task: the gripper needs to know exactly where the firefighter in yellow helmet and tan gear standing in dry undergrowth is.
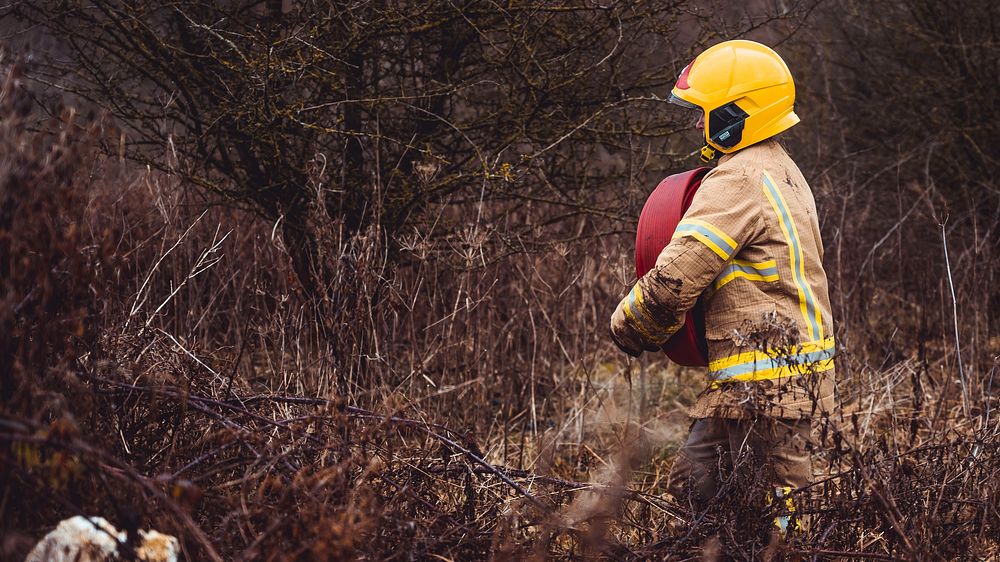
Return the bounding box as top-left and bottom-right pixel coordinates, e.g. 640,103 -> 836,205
611,40 -> 834,548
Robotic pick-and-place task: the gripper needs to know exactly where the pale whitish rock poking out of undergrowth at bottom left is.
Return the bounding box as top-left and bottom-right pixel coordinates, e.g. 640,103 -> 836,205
24,515 -> 180,562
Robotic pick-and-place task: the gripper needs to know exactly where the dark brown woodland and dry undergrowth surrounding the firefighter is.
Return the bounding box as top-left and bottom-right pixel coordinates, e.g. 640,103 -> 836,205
0,0 -> 1000,561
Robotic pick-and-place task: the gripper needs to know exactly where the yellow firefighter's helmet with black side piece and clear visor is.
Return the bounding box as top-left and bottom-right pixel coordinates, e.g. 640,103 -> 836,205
670,39 -> 799,162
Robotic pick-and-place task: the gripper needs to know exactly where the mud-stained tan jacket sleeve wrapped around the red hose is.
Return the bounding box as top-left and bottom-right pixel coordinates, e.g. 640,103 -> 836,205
611,164 -> 763,355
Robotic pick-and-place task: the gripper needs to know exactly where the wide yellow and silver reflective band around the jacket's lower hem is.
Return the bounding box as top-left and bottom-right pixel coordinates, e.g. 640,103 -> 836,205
708,337 -> 835,382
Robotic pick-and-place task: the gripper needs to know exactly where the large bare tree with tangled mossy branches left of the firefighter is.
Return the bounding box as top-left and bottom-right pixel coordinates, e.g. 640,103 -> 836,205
10,0 -> 717,296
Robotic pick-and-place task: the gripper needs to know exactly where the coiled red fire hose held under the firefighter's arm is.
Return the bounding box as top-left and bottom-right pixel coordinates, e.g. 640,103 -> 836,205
635,168 -> 709,367
